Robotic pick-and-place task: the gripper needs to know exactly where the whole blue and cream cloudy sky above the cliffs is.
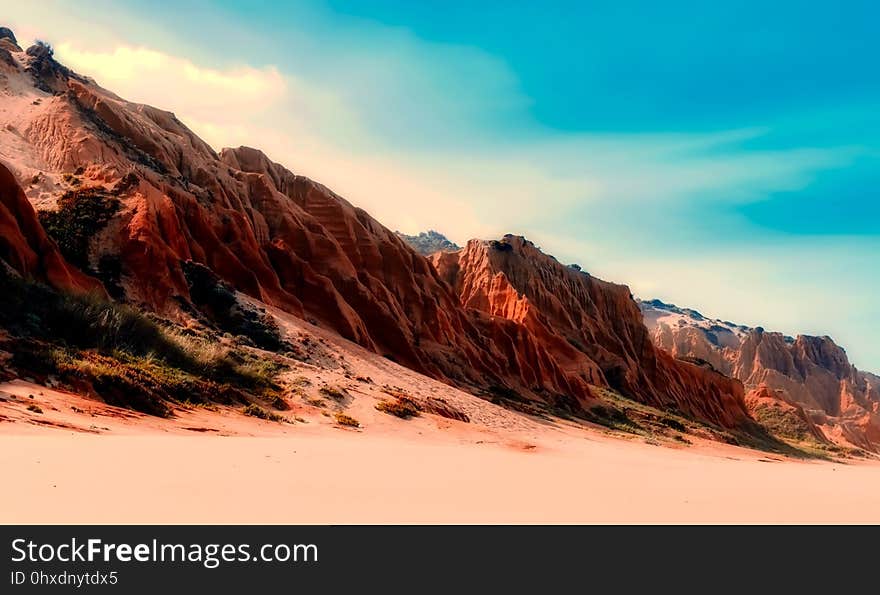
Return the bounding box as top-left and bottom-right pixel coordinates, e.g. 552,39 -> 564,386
3,0 -> 880,371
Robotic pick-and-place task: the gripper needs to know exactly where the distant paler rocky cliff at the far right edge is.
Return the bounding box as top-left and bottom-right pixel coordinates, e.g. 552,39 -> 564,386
639,300 -> 880,450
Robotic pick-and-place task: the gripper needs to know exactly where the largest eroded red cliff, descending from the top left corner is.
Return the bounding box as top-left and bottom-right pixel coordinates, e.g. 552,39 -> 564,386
0,36 -> 592,410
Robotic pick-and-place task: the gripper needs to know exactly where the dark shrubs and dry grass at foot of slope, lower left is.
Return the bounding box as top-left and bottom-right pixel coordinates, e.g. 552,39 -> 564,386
0,273 -> 279,416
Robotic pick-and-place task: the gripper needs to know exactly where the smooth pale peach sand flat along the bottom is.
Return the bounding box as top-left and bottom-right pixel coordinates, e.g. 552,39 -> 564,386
0,402 -> 880,524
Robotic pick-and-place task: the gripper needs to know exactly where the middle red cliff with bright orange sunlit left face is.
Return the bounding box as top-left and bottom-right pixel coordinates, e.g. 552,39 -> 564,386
432,236 -> 748,427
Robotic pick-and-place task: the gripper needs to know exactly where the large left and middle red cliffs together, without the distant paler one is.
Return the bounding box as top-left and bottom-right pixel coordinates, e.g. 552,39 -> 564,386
0,30 -> 768,429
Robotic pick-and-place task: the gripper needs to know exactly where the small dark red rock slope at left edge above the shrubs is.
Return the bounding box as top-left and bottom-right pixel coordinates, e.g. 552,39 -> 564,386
0,164 -> 103,293
